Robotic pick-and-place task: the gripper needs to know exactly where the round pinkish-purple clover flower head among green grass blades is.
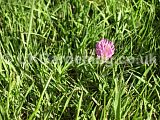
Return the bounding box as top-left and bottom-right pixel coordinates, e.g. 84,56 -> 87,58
96,39 -> 115,59
